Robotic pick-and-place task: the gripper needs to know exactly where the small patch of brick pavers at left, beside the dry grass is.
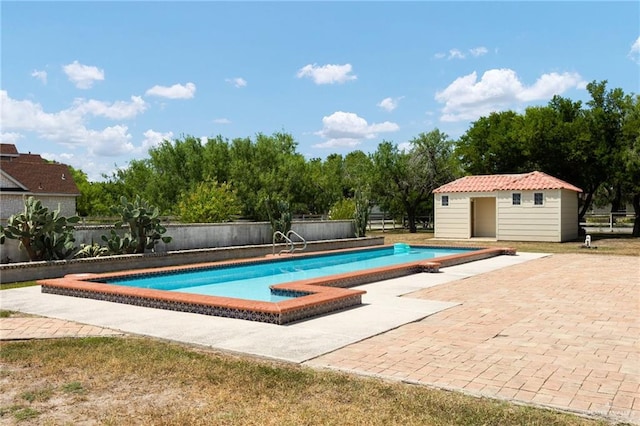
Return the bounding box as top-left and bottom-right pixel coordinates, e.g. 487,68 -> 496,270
0,316 -> 124,340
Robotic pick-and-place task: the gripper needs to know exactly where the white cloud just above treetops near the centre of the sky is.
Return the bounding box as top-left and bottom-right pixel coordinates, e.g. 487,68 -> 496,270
314,111 -> 400,148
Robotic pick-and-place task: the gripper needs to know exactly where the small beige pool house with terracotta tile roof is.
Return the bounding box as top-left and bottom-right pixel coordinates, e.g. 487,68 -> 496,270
433,171 -> 582,242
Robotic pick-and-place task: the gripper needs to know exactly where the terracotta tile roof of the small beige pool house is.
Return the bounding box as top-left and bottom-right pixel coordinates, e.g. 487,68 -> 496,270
433,171 -> 582,193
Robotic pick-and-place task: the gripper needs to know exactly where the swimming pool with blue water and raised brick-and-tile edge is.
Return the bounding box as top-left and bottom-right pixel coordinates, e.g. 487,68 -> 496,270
38,245 -> 513,324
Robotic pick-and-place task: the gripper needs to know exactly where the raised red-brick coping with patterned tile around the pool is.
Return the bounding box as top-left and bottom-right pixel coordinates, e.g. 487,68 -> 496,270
38,244 -> 515,325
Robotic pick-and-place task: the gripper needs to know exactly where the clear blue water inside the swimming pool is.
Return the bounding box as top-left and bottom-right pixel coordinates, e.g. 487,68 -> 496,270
106,244 -> 473,302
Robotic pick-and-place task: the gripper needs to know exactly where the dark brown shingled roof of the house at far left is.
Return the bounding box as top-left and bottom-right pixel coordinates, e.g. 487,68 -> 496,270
0,144 -> 80,195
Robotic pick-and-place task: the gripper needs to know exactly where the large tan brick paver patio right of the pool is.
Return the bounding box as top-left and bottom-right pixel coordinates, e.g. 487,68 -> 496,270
308,254 -> 640,423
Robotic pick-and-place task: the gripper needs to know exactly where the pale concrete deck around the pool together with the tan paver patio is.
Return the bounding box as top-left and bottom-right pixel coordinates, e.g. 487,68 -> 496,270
0,253 -> 640,423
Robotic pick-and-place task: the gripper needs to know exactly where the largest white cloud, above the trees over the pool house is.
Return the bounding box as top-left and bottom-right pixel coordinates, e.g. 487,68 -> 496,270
435,69 -> 586,121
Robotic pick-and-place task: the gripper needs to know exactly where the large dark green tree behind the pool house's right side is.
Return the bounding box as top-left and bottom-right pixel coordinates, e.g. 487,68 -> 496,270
456,81 -> 632,220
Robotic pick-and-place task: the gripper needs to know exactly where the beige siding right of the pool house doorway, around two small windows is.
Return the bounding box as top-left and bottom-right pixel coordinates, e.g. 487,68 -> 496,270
497,190 -> 561,241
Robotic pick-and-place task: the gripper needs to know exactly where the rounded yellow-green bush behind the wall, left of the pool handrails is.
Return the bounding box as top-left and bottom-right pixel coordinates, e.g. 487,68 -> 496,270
176,180 -> 242,223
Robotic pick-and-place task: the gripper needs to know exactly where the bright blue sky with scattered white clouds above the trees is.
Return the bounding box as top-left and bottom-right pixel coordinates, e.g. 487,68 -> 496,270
0,0 -> 640,181
